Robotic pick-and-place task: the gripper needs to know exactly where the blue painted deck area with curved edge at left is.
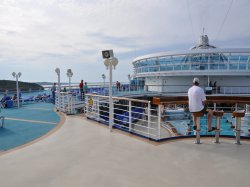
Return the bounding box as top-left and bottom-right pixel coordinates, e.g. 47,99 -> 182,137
0,103 -> 60,151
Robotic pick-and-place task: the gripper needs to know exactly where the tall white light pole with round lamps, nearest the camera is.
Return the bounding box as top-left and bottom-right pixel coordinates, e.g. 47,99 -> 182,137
104,56 -> 118,131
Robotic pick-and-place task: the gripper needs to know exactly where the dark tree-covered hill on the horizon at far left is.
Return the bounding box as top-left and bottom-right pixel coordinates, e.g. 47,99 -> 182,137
0,80 -> 44,92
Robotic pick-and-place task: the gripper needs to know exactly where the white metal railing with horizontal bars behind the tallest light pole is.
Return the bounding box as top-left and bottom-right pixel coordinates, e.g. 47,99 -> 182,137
85,94 -> 161,140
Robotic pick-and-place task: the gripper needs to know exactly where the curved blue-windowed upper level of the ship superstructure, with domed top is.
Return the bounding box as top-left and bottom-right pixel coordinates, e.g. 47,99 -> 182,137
133,35 -> 250,77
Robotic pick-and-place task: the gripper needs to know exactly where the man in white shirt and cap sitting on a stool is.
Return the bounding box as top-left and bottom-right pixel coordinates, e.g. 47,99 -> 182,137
188,77 -> 215,132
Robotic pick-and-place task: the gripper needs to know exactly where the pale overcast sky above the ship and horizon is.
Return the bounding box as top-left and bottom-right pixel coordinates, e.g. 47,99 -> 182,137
0,0 -> 250,82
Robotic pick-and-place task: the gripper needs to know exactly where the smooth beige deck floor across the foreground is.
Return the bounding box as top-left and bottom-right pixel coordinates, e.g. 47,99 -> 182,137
0,113 -> 250,187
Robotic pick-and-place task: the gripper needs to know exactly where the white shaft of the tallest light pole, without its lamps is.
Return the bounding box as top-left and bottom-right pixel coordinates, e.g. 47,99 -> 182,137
109,60 -> 113,131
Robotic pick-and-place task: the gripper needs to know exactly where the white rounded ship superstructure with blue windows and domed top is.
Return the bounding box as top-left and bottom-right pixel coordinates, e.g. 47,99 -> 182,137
133,35 -> 250,94
